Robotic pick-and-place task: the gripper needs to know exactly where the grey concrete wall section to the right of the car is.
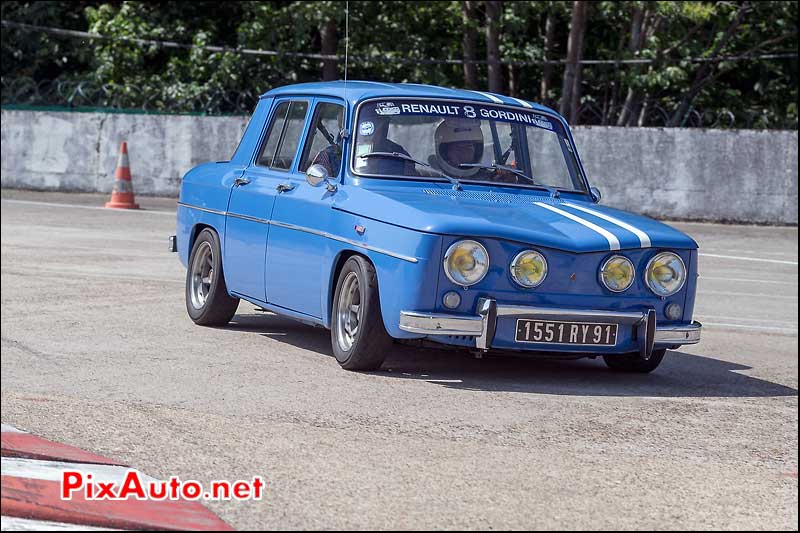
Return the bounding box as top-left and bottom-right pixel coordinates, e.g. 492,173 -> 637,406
574,127 -> 797,224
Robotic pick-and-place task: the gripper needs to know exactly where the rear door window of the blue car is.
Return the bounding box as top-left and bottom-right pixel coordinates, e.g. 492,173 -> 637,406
258,101 -> 308,170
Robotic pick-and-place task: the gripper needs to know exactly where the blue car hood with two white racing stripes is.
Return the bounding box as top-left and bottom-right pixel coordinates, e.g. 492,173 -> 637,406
333,183 -> 697,252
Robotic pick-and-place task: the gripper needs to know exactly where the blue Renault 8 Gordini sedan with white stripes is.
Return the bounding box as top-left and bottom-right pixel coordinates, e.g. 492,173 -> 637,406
170,81 -> 701,372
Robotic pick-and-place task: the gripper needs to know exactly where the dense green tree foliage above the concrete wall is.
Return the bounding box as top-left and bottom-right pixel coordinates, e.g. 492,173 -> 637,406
2,1 -> 798,128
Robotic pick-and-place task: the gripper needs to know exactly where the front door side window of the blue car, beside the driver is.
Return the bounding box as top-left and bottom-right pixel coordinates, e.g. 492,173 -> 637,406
299,102 -> 344,176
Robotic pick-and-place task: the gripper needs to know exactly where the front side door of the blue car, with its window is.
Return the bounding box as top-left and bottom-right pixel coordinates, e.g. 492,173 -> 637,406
266,98 -> 344,318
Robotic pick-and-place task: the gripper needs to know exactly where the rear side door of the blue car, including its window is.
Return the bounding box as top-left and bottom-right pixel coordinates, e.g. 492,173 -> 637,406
224,98 -> 310,302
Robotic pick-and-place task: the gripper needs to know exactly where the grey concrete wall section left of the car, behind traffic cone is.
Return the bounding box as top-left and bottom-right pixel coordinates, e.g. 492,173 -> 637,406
0,109 -> 247,196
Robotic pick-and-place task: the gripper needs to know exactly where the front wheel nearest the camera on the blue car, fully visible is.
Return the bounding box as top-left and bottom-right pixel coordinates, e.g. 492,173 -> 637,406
331,255 -> 392,371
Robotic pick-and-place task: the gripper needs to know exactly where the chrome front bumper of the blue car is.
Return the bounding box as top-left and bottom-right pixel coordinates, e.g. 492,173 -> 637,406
400,298 -> 702,358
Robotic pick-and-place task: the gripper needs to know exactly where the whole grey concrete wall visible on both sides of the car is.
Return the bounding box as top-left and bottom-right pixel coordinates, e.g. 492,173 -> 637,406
1,110 -> 798,224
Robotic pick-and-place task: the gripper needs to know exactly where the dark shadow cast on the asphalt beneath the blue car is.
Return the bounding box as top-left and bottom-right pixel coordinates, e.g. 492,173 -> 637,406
224,313 -> 798,398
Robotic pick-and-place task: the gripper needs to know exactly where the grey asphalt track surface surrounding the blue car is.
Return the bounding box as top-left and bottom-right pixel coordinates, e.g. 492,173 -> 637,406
0,191 -> 798,530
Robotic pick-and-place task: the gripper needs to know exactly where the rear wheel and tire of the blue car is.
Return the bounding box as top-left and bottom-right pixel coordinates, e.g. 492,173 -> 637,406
186,228 -> 239,326
